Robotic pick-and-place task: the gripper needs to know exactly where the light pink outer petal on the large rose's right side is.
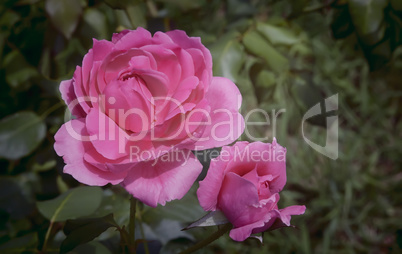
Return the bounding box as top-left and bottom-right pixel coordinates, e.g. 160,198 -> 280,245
190,77 -> 244,150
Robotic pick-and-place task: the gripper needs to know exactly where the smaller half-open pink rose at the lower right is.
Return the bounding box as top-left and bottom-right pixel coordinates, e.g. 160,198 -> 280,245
197,139 -> 306,241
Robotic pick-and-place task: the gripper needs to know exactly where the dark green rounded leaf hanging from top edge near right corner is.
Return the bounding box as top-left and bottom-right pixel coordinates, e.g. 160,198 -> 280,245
349,0 -> 388,35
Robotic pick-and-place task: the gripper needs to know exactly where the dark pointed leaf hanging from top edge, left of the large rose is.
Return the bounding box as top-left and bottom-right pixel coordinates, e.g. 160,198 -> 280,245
45,0 -> 82,39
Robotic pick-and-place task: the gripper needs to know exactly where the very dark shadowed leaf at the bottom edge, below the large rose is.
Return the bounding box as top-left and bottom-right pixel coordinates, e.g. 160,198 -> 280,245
60,214 -> 118,253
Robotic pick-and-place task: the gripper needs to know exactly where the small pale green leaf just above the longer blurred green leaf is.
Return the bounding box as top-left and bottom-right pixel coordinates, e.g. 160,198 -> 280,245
257,22 -> 299,46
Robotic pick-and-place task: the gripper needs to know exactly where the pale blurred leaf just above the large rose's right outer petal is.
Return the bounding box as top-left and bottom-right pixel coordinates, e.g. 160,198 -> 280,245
210,30 -> 246,82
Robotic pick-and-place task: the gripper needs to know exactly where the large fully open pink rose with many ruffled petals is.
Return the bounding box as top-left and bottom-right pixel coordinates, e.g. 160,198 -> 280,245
54,28 -> 244,207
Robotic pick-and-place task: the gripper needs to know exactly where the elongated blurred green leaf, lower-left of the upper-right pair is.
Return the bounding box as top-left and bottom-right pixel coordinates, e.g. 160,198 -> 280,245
243,31 -> 289,72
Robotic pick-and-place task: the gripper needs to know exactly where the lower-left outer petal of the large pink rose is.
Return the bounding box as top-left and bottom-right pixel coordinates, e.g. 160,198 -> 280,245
54,118 -> 126,186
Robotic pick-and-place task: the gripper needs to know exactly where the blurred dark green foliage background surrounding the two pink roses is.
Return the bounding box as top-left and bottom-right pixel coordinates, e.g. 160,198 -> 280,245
0,0 -> 402,254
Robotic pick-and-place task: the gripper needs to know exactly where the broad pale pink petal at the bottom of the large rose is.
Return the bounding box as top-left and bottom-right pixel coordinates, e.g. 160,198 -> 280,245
122,150 -> 202,207
